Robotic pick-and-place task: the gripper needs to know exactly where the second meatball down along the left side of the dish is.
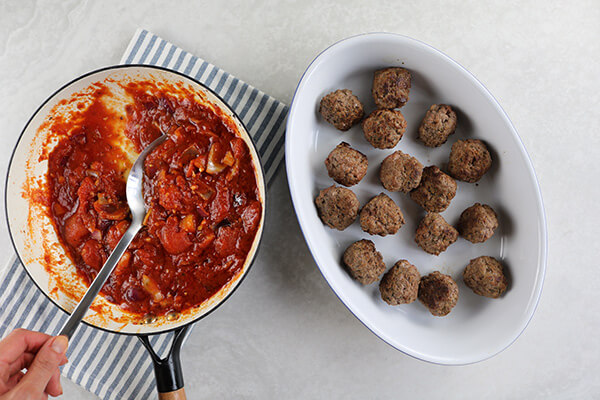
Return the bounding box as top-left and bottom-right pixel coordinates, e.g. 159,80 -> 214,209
325,142 -> 369,186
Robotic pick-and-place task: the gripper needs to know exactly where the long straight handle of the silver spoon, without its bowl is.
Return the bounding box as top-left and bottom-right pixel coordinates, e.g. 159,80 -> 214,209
59,220 -> 141,339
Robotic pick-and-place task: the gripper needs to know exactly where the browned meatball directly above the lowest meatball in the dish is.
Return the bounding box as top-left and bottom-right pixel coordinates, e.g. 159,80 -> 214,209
415,213 -> 458,256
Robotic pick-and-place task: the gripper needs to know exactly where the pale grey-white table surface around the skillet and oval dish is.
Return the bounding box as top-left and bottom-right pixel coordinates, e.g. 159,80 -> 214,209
0,0 -> 600,400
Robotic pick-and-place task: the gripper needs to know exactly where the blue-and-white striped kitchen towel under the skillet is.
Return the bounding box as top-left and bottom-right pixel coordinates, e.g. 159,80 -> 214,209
0,29 -> 288,400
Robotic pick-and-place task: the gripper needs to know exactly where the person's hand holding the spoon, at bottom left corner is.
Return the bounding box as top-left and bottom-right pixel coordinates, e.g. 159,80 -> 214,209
0,329 -> 69,400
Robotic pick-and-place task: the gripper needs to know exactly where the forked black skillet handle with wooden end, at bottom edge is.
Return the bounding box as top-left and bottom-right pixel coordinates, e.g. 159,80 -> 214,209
138,325 -> 190,400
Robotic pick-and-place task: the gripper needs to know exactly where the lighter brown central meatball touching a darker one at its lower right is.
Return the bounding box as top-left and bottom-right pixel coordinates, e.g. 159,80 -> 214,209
379,150 -> 423,193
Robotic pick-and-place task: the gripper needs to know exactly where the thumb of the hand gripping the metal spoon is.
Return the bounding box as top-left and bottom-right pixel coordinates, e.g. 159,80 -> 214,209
17,336 -> 69,393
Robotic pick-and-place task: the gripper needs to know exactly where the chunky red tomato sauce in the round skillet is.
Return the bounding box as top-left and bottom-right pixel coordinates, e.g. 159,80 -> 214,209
48,82 -> 262,315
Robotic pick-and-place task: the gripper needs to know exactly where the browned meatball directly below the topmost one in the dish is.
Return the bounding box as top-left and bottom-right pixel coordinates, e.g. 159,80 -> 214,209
362,110 -> 406,149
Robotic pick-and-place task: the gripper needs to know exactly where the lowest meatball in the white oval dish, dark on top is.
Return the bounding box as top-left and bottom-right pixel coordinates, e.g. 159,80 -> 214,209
419,271 -> 458,317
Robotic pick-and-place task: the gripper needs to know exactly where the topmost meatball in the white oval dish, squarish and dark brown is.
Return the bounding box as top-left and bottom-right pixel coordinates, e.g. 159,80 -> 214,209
371,68 -> 410,108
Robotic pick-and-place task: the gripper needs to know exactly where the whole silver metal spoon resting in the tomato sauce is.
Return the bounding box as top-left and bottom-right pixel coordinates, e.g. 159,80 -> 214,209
59,135 -> 167,339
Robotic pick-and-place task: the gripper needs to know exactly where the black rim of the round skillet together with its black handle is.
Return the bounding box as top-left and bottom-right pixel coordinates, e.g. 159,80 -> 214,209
4,64 -> 267,393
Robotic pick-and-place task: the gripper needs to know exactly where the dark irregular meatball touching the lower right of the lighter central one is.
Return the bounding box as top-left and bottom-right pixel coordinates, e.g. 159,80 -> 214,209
410,165 -> 457,212
